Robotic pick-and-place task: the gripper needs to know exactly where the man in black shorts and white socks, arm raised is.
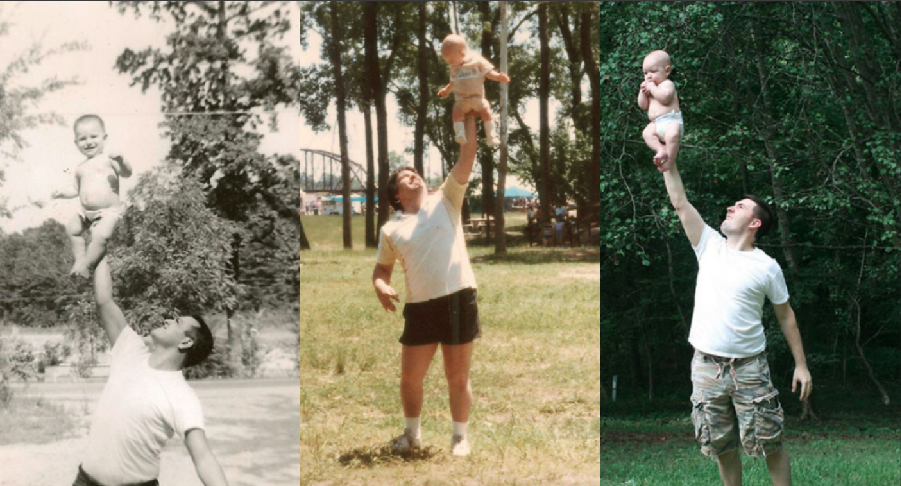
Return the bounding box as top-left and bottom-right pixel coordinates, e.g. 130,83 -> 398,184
372,118 -> 481,456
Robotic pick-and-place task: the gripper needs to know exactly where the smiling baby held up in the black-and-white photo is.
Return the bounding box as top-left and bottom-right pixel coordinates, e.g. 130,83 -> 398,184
50,115 -> 132,278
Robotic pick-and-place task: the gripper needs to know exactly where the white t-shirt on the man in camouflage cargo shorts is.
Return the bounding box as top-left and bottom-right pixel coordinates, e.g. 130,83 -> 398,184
688,225 -> 788,358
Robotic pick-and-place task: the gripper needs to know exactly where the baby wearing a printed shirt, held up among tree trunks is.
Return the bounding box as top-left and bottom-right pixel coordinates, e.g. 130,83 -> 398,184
438,34 -> 510,145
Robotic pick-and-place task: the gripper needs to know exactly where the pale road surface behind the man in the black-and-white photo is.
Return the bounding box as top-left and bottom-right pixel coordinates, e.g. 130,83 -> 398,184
0,378 -> 300,486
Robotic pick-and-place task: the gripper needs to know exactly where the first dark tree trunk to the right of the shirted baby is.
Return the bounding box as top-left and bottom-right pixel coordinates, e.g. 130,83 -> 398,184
538,3 -> 552,220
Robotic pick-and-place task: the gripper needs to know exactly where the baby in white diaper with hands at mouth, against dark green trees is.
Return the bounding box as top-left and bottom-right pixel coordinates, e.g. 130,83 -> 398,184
638,51 -> 684,172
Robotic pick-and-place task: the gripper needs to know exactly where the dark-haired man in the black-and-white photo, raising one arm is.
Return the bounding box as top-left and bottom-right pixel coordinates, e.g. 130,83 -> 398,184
73,258 -> 227,486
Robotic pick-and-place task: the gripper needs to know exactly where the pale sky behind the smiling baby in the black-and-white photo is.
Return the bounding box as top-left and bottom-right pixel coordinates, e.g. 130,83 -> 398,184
0,2 -> 303,232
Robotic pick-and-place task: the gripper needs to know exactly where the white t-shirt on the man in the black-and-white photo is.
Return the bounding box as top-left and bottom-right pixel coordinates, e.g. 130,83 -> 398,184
82,326 -> 204,486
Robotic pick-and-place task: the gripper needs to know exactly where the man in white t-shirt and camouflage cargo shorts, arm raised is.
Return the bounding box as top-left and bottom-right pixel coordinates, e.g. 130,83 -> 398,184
659,160 -> 812,486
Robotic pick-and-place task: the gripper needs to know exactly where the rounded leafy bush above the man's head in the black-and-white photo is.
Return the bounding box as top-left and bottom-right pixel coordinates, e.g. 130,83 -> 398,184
112,167 -> 240,333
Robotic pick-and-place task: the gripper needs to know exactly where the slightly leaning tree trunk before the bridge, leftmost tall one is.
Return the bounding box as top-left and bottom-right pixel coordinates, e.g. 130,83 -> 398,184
329,0 -> 354,250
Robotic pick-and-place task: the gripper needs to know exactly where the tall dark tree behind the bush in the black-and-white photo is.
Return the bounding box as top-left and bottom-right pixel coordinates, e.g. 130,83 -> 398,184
116,1 -> 305,356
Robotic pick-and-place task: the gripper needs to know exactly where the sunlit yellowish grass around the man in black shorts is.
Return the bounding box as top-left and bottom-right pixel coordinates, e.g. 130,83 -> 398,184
300,217 -> 601,486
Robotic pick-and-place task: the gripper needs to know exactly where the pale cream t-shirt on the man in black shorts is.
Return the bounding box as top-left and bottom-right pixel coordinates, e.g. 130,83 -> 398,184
376,176 -> 476,303
